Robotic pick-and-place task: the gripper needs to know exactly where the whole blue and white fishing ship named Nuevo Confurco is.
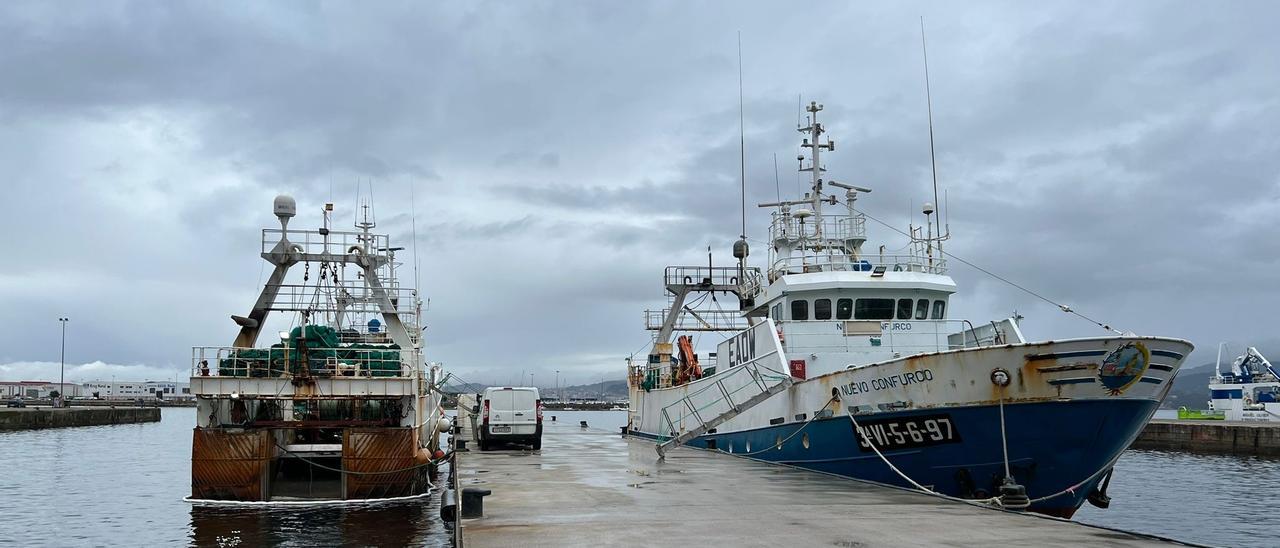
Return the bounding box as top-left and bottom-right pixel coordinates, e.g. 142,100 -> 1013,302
628,104 -> 1192,517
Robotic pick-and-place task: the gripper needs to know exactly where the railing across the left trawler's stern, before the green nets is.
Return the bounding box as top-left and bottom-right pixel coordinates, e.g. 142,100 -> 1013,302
191,346 -> 416,379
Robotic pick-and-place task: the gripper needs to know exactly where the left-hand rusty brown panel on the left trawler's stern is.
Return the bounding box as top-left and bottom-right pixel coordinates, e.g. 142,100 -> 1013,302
191,428 -> 271,501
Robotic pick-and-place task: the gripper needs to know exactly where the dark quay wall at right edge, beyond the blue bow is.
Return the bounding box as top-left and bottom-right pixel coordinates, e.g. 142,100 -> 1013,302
1133,419 -> 1280,457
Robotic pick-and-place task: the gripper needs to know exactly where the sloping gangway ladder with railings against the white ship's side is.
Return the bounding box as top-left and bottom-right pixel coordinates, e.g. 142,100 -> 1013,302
657,352 -> 795,460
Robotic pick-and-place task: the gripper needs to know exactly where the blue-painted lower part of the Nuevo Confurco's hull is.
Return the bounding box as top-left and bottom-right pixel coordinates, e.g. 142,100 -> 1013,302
634,398 -> 1158,517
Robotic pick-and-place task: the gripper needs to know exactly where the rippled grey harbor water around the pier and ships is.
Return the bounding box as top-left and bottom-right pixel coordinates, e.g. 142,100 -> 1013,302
0,408 -> 1280,547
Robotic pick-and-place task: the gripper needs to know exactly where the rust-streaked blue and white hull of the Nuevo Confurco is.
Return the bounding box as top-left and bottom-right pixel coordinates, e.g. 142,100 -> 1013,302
628,321 -> 1192,517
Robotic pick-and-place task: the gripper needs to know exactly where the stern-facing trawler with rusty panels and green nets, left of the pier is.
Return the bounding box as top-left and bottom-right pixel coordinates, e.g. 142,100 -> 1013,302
191,196 -> 448,502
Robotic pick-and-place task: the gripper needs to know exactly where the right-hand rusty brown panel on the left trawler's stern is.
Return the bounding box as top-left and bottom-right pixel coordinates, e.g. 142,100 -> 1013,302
342,428 -> 430,499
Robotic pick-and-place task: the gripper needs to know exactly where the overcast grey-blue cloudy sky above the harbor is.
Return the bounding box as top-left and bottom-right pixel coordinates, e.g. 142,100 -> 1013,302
0,1 -> 1280,385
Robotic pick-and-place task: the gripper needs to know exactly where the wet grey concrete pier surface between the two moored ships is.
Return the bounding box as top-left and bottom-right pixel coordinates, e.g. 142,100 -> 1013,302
458,420 -> 1176,547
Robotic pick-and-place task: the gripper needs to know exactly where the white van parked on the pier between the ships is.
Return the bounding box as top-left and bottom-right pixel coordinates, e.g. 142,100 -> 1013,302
479,387 -> 543,451
